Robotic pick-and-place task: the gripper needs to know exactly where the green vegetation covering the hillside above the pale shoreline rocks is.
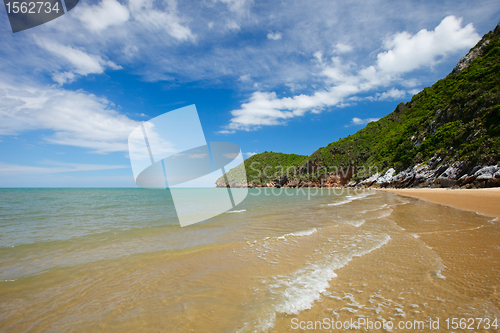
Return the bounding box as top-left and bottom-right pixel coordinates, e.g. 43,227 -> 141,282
218,21 -> 500,183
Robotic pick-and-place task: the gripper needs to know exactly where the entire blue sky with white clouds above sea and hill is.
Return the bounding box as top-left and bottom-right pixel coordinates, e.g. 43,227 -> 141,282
0,0 -> 500,187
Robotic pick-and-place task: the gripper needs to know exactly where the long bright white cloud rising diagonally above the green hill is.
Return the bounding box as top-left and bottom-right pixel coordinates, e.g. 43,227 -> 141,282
224,16 -> 479,131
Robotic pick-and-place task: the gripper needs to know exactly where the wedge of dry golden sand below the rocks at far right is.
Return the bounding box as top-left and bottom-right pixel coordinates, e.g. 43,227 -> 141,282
382,187 -> 500,218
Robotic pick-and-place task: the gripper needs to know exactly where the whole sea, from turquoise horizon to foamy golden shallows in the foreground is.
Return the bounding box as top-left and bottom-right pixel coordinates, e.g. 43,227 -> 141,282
0,188 -> 500,332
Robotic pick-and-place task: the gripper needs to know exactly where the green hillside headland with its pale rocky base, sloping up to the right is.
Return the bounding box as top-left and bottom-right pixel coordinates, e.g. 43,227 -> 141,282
218,23 -> 500,187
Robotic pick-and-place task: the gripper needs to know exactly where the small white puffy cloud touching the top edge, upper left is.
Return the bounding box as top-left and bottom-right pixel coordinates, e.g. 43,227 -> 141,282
78,0 -> 130,32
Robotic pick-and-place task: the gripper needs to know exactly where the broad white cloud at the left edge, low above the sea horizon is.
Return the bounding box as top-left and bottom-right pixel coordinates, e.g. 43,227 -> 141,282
0,83 -> 139,153
